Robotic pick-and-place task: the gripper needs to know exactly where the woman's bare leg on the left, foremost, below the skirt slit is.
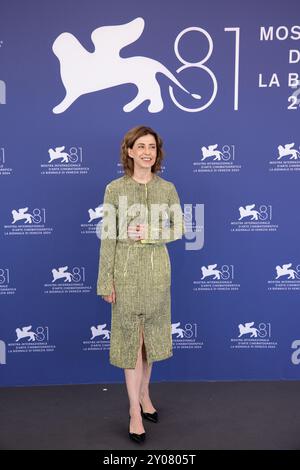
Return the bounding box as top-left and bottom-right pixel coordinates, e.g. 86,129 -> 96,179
124,326 -> 145,434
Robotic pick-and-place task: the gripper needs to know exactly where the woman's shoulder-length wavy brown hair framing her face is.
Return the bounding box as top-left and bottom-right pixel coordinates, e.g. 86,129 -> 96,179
121,126 -> 164,176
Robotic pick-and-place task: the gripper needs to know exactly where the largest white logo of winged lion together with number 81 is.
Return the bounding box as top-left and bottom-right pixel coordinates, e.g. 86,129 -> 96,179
52,17 -> 240,114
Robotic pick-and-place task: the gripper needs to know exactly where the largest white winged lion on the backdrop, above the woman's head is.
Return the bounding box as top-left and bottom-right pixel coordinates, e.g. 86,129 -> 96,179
52,18 -> 201,114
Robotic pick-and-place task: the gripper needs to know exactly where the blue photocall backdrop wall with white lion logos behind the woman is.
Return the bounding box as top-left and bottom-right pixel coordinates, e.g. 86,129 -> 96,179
0,0 -> 300,386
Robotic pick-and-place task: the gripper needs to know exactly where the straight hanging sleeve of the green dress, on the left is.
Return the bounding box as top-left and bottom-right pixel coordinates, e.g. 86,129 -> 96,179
97,184 -> 117,295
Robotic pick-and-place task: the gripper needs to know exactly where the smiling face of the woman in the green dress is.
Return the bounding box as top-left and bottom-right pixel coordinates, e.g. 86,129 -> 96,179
128,134 -> 157,169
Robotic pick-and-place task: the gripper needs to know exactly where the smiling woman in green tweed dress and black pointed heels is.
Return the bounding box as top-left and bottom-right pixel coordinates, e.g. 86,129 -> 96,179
97,126 -> 184,443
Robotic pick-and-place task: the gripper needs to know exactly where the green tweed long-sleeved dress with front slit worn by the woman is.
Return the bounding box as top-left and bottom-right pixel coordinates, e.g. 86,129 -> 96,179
97,174 -> 184,369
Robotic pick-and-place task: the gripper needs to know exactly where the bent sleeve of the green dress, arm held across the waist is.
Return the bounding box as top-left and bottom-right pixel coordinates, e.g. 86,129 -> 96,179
140,183 -> 185,244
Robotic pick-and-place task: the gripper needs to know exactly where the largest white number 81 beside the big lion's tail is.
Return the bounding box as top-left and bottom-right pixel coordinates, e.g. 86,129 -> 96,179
169,26 -> 240,113
